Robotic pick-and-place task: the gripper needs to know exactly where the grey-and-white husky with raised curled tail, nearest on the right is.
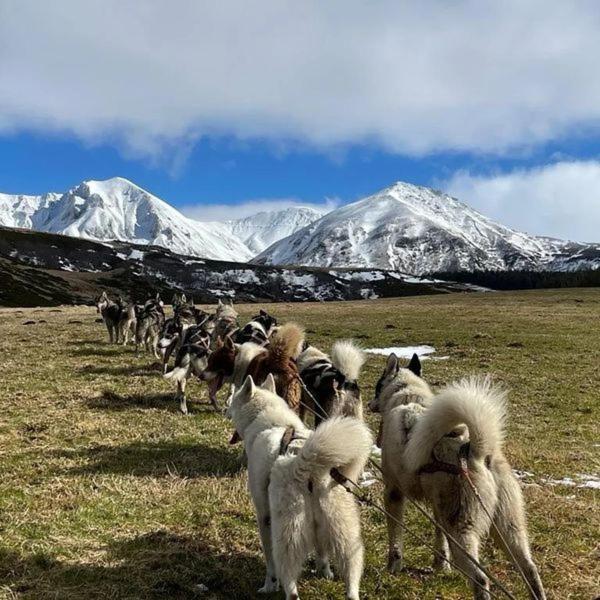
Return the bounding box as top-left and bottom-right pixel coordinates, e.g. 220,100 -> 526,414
369,354 -> 546,600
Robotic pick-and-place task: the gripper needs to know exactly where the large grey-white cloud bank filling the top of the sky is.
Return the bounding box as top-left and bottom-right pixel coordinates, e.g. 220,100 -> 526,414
0,0 -> 600,160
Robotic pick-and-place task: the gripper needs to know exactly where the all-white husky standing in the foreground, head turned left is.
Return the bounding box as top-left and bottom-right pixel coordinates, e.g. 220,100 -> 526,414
227,374 -> 372,600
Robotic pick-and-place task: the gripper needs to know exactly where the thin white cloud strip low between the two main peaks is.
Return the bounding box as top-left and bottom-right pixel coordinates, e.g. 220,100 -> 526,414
179,198 -> 339,221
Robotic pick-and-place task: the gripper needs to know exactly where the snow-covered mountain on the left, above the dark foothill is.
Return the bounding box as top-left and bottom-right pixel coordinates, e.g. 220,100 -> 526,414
0,177 -> 253,261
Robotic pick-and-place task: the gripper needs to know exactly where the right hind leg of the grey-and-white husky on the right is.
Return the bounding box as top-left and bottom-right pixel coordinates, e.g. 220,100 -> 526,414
492,479 -> 546,600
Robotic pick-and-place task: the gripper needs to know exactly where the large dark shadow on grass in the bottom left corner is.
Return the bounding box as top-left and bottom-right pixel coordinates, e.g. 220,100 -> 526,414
0,531 -> 264,600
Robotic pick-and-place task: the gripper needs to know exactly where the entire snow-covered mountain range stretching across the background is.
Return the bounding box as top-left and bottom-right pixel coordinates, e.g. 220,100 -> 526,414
0,177 -> 600,275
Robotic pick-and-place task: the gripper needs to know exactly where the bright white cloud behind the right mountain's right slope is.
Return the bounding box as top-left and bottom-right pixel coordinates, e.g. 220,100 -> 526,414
440,161 -> 600,242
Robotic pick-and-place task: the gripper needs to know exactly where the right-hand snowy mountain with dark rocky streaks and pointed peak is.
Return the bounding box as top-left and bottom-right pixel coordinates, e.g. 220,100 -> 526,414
254,182 -> 600,274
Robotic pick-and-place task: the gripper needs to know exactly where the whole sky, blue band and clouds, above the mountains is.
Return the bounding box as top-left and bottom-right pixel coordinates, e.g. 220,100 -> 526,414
0,0 -> 600,241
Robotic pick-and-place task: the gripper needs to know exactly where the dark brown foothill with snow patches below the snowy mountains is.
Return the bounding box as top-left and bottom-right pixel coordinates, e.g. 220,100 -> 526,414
0,228 -> 481,306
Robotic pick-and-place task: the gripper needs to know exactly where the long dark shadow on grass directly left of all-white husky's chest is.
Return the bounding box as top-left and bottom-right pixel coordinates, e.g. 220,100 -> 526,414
53,436 -> 241,478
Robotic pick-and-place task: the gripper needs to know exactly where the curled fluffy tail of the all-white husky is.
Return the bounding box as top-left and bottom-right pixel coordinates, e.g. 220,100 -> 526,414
294,417 -> 373,481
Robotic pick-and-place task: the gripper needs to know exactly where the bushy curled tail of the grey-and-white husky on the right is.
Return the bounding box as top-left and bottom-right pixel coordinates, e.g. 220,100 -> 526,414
404,377 -> 506,471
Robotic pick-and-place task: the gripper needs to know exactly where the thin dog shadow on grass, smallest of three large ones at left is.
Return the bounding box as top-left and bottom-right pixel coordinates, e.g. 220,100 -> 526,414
85,390 -> 215,418
